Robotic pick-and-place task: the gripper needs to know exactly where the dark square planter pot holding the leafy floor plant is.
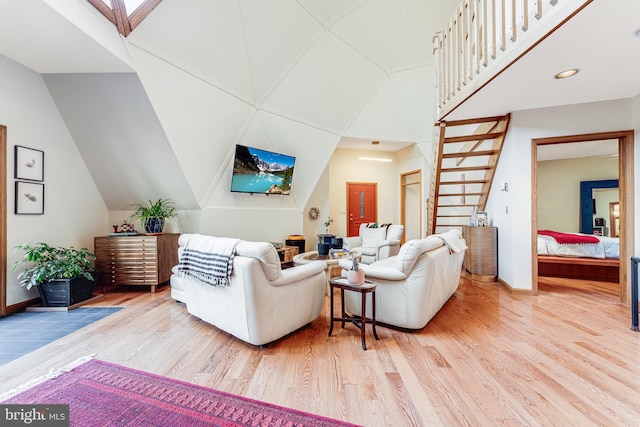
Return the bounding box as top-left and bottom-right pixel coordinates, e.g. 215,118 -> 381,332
36,273 -> 98,307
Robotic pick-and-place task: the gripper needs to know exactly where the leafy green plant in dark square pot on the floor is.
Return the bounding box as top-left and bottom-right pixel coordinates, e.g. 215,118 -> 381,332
13,243 -> 98,307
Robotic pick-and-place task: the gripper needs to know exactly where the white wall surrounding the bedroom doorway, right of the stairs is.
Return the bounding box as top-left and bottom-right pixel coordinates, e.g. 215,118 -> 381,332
487,99 -> 640,289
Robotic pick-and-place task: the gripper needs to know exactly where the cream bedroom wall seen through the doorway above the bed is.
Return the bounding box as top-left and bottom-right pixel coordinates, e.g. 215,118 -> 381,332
537,156 -> 618,233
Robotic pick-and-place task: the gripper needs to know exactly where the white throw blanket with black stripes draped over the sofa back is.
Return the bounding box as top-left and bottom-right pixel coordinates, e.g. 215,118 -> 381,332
178,234 -> 241,286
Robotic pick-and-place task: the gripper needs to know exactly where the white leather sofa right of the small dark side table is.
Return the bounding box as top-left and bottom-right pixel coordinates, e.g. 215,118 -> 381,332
339,230 -> 467,329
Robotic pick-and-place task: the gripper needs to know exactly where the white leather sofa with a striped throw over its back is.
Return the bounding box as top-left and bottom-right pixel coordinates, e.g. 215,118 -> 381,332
170,234 -> 326,346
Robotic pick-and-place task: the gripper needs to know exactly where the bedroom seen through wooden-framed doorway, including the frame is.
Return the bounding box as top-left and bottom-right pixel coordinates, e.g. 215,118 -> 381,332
532,131 -> 634,301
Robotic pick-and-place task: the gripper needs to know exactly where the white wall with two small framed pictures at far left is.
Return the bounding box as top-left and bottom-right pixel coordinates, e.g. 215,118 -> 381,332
0,56 -> 110,305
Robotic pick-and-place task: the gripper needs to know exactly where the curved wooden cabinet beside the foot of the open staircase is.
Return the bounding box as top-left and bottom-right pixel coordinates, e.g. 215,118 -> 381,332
462,225 -> 498,282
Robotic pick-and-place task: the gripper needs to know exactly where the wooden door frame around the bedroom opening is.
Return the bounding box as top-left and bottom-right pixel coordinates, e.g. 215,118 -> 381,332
531,130 -> 635,303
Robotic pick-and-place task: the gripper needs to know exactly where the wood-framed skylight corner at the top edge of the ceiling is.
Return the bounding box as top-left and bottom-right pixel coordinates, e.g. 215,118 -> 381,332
87,0 -> 162,37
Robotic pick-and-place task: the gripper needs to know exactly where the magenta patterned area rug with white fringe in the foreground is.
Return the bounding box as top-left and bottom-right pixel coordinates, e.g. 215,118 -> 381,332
0,357 -> 354,427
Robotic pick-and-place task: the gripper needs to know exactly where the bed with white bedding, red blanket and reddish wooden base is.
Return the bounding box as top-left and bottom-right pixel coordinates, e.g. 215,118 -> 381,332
538,230 -> 620,282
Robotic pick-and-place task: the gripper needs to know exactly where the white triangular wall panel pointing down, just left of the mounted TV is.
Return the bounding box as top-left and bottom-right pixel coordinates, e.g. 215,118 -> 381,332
130,47 -> 254,201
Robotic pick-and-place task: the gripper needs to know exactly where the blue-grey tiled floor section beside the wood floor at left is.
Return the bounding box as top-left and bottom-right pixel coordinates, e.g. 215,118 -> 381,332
0,307 -> 122,365
